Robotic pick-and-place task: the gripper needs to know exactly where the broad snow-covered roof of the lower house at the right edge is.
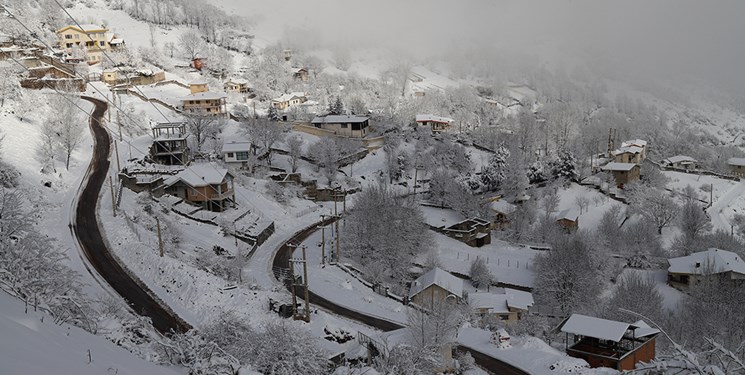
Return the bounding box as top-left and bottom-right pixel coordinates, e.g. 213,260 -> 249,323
667,248 -> 745,275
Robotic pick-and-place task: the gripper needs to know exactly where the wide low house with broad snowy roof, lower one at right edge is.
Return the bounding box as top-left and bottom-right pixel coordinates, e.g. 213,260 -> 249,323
667,248 -> 745,287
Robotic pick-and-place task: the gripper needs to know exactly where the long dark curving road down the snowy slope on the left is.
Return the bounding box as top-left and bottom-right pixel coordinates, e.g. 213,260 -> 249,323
71,97 -> 191,334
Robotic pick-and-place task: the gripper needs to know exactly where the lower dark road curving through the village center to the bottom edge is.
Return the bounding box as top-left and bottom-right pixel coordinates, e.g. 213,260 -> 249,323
272,218 -> 528,375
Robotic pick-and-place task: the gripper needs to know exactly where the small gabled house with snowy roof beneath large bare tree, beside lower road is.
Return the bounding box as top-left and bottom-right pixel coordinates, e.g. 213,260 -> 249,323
409,267 -> 463,306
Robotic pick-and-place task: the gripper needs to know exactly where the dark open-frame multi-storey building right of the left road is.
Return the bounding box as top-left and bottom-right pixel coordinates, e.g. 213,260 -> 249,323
150,122 -> 189,165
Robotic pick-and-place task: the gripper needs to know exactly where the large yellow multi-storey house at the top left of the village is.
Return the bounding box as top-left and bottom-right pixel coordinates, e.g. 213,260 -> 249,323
57,24 -> 124,65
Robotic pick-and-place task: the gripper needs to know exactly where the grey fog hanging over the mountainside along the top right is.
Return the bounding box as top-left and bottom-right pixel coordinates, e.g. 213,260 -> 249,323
234,0 -> 745,95
